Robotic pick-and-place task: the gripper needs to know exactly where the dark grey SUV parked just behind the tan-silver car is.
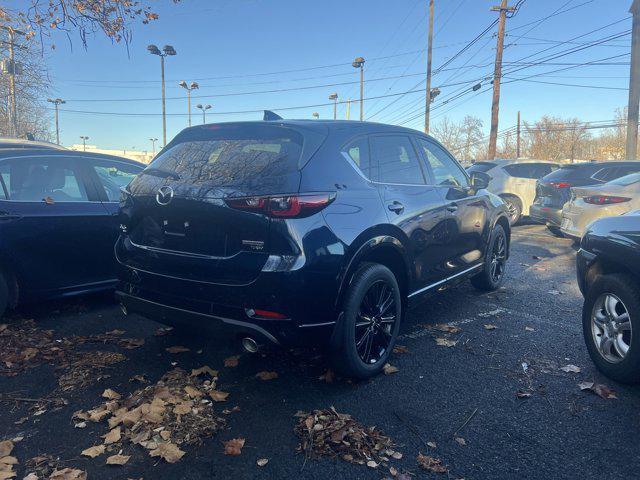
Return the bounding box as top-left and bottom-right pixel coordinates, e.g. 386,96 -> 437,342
529,162 -> 640,236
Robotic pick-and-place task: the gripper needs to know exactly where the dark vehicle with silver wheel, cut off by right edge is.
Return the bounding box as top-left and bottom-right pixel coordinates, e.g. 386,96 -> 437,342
577,211 -> 640,383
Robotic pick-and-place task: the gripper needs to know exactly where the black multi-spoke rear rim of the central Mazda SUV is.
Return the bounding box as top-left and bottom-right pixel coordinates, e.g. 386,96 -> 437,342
355,280 -> 398,365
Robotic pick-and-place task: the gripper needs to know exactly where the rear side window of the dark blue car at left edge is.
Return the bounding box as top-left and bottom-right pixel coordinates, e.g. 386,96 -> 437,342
0,157 -> 88,202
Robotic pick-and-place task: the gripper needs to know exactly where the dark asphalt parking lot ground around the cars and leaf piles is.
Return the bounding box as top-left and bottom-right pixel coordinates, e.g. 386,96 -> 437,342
0,224 -> 640,479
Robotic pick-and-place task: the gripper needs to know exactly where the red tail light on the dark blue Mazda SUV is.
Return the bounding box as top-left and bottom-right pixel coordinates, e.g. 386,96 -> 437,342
225,193 -> 336,218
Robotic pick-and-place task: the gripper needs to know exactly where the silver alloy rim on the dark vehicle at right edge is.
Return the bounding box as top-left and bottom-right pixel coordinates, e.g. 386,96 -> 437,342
591,293 -> 632,363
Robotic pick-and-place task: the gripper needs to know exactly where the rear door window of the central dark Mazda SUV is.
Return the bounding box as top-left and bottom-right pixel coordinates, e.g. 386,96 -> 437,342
371,135 -> 424,185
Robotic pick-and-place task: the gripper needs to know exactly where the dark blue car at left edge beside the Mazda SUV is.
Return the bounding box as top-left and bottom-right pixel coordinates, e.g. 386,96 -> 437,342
0,149 -> 144,315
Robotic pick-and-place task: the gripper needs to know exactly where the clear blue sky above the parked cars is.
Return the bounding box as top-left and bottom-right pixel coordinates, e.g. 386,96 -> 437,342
15,0 -> 631,150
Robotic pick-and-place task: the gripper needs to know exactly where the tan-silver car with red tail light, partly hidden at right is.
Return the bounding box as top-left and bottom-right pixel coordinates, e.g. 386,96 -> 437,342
560,173 -> 640,240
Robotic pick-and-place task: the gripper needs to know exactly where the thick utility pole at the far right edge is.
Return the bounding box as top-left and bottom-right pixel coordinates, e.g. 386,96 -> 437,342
626,0 -> 640,160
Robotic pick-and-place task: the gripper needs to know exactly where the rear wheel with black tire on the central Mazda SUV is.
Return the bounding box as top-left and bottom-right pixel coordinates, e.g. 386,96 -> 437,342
330,263 -> 402,379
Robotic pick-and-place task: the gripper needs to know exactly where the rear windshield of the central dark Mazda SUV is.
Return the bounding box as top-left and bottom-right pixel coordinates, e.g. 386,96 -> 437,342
145,125 -> 303,186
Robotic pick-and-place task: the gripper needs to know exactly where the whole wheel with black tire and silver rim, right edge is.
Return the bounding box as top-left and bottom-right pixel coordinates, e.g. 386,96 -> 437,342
582,273 -> 640,383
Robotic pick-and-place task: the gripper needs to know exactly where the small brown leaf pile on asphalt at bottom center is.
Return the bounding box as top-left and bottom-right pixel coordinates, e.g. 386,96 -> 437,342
294,407 -> 399,468
